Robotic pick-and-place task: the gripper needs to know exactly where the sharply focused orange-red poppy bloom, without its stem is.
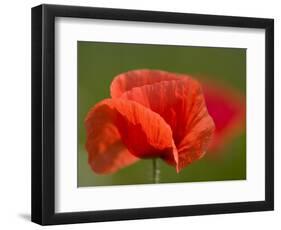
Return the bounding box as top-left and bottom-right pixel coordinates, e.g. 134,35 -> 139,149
85,70 -> 214,173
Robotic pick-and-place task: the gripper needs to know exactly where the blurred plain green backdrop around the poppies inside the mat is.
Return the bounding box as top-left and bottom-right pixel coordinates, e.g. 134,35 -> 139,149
77,41 -> 246,187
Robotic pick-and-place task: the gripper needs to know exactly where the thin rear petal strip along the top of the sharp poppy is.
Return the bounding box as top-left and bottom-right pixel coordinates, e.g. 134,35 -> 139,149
110,69 -> 185,98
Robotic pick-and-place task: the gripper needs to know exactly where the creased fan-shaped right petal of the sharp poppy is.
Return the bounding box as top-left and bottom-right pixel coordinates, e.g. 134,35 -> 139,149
121,77 -> 214,171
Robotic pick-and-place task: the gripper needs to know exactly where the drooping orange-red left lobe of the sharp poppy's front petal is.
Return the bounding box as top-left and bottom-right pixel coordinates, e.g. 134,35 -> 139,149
85,110 -> 138,174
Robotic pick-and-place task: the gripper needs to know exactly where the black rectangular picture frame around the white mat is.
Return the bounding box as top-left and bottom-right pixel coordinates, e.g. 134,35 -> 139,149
31,5 -> 274,225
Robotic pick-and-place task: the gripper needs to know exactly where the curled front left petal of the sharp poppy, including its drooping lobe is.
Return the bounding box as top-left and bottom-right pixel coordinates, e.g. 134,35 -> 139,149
85,99 -> 178,173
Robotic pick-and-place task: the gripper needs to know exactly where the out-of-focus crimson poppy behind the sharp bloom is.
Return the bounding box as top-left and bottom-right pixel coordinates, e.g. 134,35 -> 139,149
202,83 -> 246,152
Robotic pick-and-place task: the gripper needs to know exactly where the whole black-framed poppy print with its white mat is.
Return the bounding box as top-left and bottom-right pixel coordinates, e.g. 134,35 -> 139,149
32,5 -> 274,225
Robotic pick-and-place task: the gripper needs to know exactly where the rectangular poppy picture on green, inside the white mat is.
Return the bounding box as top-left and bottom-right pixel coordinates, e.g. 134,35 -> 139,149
77,40 -> 247,187
